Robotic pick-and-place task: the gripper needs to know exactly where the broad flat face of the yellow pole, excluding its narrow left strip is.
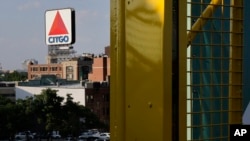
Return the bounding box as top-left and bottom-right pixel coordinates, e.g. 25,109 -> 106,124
124,0 -> 172,141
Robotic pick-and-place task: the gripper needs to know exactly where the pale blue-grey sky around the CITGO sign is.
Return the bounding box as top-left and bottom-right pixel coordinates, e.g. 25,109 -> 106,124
0,0 -> 110,70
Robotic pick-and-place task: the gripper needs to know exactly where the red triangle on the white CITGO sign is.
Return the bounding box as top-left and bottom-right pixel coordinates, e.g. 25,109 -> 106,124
49,11 -> 68,35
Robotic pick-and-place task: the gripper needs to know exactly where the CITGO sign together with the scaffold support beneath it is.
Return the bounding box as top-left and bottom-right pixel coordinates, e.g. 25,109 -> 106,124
45,8 -> 75,63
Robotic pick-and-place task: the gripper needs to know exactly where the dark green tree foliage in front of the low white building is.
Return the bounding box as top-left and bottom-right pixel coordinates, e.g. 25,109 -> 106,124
0,89 -> 104,139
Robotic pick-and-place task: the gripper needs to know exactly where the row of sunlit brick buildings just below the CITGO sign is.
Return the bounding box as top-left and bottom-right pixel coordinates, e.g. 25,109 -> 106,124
28,56 -> 110,82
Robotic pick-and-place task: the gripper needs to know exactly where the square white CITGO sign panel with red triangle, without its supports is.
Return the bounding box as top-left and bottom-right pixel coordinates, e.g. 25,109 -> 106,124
45,8 -> 75,45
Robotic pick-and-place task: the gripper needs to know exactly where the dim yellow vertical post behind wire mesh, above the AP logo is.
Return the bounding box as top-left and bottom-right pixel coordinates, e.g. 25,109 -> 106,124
229,0 -> 243,124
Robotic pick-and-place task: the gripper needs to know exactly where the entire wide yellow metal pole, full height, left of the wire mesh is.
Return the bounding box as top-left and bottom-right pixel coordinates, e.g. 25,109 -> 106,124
110,0 -> 181,141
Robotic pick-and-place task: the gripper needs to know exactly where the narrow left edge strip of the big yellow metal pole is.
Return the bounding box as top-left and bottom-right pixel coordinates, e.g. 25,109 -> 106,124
110,0 -> 126,141
